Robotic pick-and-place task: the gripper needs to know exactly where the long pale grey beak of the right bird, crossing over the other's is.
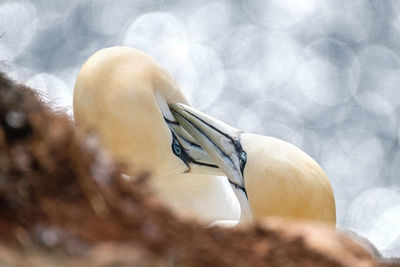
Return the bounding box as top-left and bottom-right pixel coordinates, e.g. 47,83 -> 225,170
169,103 -> 247,193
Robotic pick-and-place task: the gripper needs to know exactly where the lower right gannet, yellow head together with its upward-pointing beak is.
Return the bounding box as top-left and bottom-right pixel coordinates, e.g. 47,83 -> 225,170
169,103 -> 336,225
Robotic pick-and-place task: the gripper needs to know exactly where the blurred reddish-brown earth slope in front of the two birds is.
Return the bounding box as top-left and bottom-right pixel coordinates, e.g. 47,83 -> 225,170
0,71 -> 400,266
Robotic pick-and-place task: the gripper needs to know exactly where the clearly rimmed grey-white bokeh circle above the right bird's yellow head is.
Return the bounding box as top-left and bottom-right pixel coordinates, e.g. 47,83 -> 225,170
297,39 -> 360,106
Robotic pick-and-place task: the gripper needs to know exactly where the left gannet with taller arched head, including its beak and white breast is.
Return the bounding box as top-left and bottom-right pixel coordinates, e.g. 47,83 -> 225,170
73,46 -> 240,225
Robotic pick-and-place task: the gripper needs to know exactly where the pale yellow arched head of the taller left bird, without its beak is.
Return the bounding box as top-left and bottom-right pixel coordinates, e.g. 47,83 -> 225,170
73,47 -> 189,178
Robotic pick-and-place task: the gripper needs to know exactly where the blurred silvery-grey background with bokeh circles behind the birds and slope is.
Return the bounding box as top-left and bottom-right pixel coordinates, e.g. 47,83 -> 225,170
0,0 -> 400,257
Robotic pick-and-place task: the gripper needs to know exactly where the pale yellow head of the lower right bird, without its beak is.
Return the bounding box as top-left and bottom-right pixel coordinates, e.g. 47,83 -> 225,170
241,133 -> 336,223
